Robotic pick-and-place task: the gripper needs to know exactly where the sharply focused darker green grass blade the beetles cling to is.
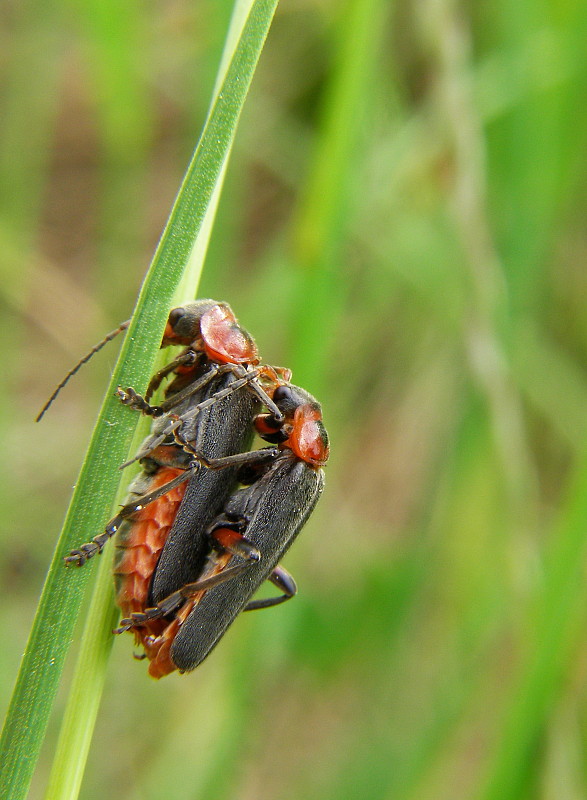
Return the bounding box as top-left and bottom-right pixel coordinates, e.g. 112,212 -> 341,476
0,0 -> 277,800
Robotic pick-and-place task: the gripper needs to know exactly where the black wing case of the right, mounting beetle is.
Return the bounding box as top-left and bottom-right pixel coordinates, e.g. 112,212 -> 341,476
171,451 -> 324,671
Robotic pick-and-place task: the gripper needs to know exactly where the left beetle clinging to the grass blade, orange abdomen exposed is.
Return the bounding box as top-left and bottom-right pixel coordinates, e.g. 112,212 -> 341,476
65,300 -> 289,664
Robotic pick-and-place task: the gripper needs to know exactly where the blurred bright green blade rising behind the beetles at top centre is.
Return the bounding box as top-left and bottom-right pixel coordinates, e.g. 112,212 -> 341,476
292,0 -> 386,394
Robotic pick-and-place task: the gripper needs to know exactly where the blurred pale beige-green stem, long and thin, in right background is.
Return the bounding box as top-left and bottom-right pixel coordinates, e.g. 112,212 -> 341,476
423,0 -> 538,564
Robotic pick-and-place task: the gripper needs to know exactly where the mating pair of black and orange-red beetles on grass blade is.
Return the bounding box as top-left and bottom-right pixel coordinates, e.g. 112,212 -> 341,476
51,300 -> 328,677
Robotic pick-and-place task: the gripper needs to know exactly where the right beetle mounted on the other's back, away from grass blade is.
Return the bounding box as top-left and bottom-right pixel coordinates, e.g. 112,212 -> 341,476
117,385 -> 329,678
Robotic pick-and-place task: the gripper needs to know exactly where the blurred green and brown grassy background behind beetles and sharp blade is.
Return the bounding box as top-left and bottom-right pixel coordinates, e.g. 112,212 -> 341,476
0,0 -> 587,800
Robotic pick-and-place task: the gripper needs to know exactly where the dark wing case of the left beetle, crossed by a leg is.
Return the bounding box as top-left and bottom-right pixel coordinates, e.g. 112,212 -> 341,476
149,373 -> 260,605
